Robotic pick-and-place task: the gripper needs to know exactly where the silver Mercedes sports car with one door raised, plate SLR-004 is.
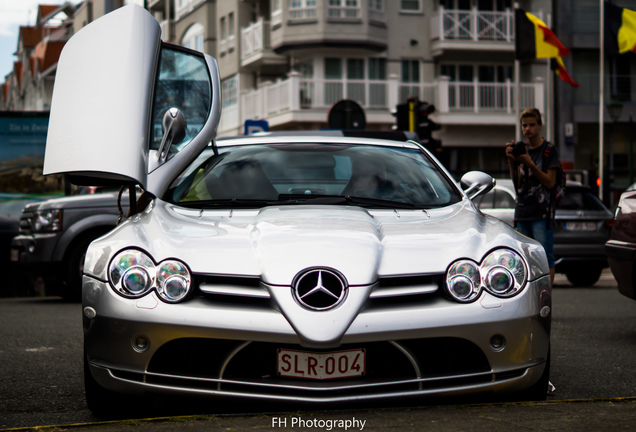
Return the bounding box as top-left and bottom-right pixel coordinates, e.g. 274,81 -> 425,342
45,5 -> 551,412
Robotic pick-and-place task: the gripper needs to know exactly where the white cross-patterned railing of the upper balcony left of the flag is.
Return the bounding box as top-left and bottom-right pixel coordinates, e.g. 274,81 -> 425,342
431,7 -> 515,42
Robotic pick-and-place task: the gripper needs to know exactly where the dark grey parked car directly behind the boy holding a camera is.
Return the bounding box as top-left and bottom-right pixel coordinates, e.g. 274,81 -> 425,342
475,179 -> 613,286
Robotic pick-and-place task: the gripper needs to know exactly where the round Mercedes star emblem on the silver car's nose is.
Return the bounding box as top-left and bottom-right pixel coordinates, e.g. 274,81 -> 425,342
293,269 -> 347,311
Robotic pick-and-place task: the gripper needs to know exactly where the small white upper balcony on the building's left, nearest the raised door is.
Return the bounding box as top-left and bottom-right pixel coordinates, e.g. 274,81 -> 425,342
241,17 -> 287,72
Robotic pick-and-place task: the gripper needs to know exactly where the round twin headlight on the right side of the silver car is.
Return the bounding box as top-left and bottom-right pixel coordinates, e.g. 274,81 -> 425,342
446,249 -> 527,303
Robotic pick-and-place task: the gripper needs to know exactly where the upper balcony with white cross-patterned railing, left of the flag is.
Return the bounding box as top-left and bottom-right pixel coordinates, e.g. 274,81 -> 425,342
431,7 -> 515,55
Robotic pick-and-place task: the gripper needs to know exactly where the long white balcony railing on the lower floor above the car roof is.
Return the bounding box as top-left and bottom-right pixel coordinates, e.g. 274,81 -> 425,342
231,73 -> 545,131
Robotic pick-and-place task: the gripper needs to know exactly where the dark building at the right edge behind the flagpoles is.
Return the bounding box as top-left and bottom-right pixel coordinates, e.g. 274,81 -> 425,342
554,0 -> 636,197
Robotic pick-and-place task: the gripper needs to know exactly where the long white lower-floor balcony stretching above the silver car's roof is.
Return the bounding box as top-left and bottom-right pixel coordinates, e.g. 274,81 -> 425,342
219,72 -> 545,134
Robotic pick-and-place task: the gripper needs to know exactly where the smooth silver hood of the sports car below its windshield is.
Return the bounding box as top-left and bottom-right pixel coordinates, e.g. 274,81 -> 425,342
92,200 -> 547,286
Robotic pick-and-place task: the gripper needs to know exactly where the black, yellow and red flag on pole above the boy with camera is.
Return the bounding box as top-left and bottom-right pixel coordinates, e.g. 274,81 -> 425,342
515,9 -> 580,88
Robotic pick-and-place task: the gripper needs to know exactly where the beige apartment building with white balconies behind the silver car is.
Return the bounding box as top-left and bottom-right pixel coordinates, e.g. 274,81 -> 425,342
147,0 -> 552,174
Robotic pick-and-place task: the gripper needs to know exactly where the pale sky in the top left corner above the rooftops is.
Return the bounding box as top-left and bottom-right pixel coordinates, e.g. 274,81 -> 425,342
0,0 -> 81,83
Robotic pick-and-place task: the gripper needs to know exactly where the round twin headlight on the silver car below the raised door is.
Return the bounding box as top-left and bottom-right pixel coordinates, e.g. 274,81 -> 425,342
108,249 -> 192,303
